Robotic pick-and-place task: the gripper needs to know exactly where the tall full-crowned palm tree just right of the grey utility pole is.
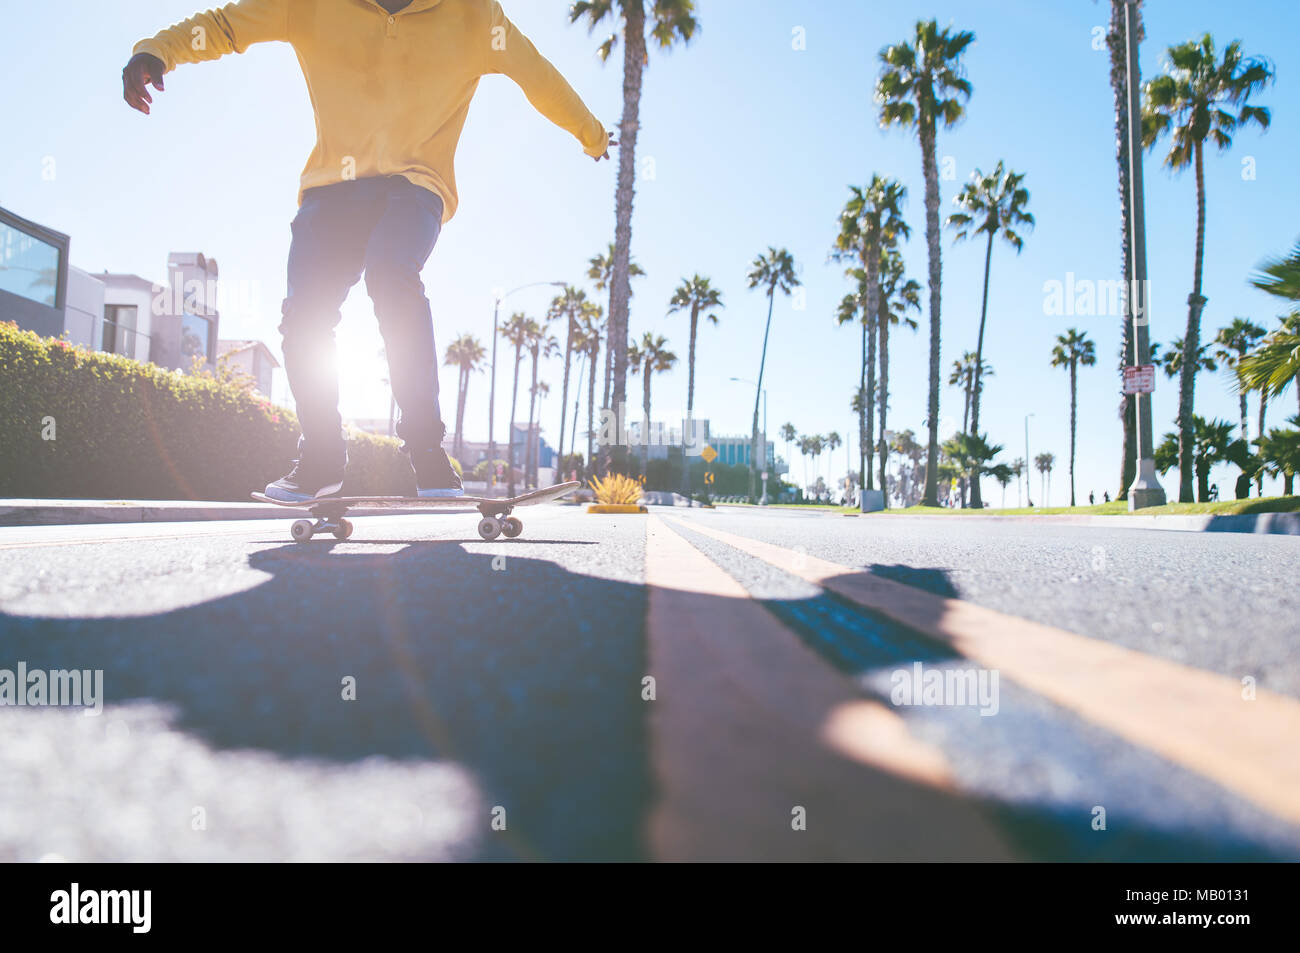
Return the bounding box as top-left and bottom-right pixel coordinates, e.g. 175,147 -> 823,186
1141,34 -> 1273,503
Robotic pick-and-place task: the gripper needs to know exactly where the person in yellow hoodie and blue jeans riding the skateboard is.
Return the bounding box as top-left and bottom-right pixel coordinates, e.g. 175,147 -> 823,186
122,0 -> 618,502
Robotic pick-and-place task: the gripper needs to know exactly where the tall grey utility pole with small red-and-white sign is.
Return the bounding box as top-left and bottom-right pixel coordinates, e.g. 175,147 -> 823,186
1125,0 -> 1165,512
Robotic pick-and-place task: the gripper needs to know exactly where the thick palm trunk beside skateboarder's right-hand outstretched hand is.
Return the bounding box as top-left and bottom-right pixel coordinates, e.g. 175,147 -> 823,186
603,0 -> 646,468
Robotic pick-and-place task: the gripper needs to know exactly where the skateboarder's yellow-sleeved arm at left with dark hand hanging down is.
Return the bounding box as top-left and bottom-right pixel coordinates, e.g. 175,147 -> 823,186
122,0 -> 289,114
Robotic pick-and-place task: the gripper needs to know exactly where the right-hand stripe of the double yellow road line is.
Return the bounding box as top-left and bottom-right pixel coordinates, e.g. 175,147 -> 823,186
665,520 -> 1300,823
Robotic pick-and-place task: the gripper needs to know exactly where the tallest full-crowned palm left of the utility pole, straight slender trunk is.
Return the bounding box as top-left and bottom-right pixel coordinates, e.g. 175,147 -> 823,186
875,20 -> 975,506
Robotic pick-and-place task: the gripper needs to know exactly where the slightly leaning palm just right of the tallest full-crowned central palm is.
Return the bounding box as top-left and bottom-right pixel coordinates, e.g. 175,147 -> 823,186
948,161 -> 1034,510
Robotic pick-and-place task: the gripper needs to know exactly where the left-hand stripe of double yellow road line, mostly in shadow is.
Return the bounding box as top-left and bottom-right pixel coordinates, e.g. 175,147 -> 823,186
646,516 -> 1017,861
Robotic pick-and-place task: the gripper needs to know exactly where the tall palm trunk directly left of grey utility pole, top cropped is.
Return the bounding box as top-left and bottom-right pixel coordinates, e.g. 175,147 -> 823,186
1106,0 -> 1145,499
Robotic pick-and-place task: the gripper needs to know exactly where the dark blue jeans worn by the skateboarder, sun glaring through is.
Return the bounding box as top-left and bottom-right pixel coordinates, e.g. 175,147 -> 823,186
280,176 -> 445,467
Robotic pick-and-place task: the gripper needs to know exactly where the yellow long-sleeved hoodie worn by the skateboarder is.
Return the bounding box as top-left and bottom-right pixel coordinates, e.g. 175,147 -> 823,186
134,0 -> 608,222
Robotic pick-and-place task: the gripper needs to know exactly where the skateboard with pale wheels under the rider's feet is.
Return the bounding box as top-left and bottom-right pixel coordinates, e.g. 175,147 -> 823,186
252,481 -> 582,542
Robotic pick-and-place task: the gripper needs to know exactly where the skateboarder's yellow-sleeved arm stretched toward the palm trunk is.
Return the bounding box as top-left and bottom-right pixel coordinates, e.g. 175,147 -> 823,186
482,0 -> 618,160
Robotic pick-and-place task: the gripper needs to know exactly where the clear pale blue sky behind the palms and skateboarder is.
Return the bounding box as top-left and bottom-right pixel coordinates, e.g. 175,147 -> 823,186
0,0 -> 1300,503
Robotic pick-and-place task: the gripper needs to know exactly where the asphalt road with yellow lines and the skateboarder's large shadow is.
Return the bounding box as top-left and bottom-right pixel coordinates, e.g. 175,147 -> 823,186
0,506 -> 1300,861
